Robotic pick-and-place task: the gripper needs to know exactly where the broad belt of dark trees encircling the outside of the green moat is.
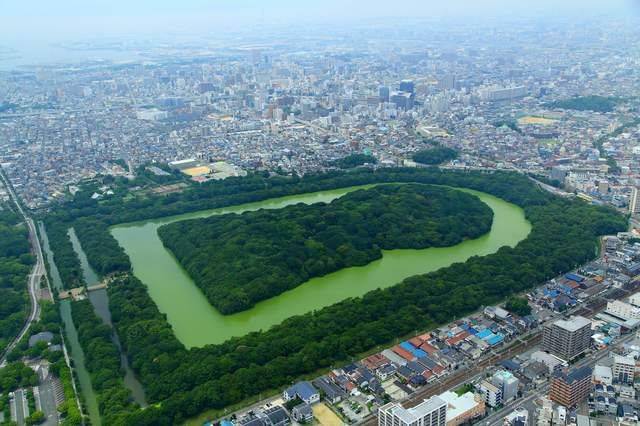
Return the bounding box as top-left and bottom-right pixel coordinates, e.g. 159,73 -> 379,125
45,168 -> 626,425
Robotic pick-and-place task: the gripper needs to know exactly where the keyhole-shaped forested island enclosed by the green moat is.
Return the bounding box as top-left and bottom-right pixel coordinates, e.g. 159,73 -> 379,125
158,184 -> 493,314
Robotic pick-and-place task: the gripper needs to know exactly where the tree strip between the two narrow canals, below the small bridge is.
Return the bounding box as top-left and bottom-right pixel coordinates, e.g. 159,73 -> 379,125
71,300 -> 139,425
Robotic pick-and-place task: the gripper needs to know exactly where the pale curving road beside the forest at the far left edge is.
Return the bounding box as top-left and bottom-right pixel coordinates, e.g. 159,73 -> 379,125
0,166 -> 48,366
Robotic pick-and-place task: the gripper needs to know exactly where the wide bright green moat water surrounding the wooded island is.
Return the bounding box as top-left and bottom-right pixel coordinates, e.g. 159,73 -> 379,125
111,185 -> 531,347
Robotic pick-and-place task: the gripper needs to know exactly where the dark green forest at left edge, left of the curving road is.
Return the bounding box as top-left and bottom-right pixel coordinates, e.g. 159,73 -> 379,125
0,204 -> 34,351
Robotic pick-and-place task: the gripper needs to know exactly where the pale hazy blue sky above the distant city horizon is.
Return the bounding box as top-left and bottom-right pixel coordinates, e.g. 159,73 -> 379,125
0,0 -> 640,43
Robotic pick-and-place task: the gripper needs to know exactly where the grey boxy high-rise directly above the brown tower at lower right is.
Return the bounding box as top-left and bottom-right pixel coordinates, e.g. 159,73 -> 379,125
542,316 -> 592,361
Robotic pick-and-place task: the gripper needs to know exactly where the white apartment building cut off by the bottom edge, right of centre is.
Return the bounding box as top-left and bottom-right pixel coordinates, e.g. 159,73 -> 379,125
378,396 -> 447,426
